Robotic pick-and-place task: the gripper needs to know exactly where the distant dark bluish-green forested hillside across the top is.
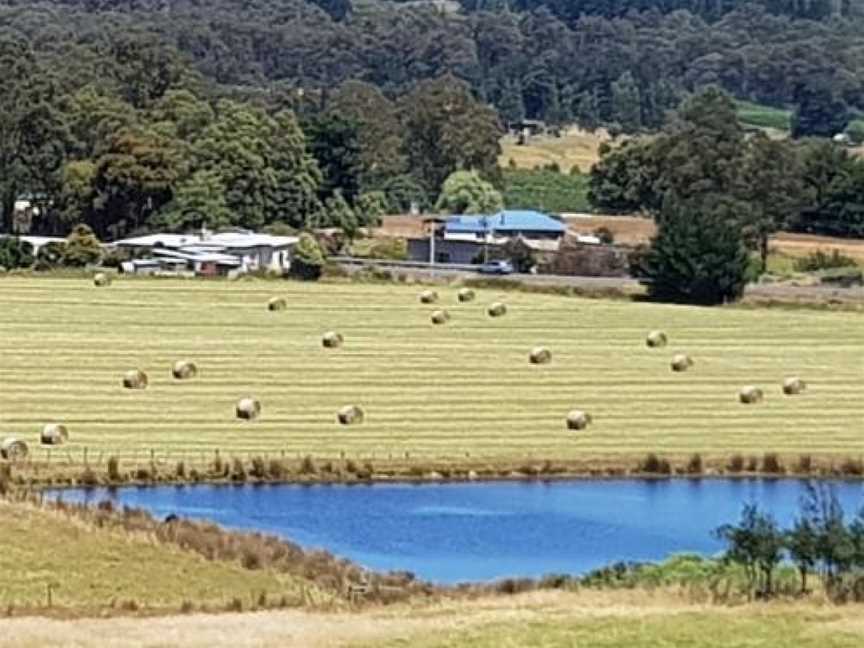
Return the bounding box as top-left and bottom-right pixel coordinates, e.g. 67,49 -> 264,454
0,0 -> 864,131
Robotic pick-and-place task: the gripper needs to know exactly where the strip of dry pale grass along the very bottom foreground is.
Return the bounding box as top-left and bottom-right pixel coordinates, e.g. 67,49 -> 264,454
0,591 -> 864,648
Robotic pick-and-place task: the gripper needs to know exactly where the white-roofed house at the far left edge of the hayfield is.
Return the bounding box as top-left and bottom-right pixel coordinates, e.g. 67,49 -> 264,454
113,230 -> 299,276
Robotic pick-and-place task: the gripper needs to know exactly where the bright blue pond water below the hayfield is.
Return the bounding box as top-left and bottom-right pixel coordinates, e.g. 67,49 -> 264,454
52,479 -> 864,583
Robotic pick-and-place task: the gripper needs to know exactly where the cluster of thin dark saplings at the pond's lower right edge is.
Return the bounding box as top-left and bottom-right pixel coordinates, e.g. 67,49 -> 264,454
715,483 -> 864,601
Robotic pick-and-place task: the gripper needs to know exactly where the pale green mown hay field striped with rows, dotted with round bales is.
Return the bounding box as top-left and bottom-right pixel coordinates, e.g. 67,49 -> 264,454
0,277 -> 864,462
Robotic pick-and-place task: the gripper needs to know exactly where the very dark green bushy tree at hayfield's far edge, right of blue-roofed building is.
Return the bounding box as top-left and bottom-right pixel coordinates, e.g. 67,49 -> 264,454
644,200 -> 748,306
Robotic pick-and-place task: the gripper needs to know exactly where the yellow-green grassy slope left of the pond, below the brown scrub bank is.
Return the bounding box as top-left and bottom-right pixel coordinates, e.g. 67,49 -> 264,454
0,500 -> 310,612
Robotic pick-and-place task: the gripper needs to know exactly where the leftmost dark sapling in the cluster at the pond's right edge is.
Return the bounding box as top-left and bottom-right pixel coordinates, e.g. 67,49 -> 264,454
714,504 -> 784,596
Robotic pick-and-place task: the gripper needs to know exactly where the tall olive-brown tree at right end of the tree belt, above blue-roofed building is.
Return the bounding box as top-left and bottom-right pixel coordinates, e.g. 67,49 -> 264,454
401,76 -> 502,193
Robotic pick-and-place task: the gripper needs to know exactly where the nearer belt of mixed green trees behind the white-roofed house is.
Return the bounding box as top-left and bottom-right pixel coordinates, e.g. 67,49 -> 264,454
0,22 -> 501,239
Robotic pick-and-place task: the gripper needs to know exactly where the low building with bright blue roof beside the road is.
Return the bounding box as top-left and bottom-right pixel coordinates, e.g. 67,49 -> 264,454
444,210 -> 567,240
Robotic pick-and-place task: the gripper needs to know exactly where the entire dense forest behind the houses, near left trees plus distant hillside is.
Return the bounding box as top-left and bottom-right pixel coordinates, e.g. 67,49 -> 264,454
0,0 -> 864,243
